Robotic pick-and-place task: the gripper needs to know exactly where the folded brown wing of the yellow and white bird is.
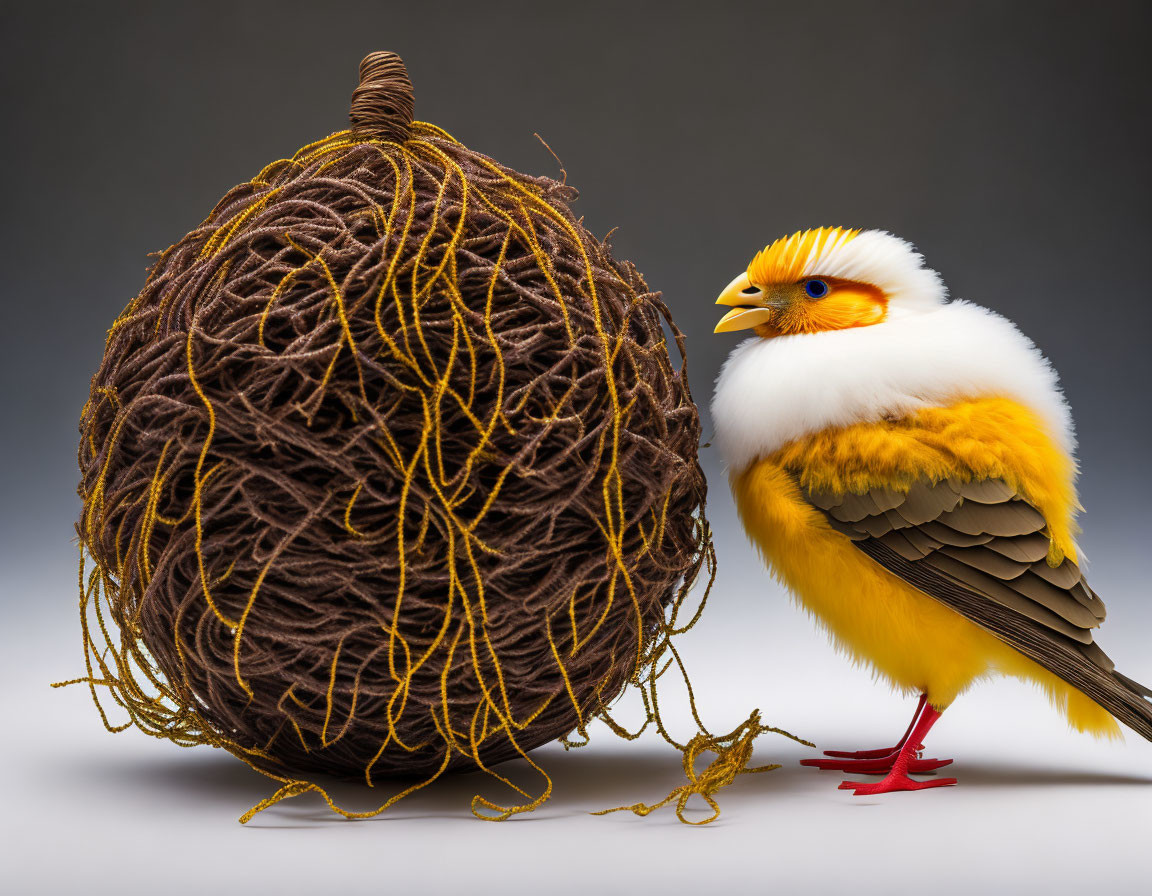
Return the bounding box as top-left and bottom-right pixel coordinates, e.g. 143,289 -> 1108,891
797,479 -> 1152,738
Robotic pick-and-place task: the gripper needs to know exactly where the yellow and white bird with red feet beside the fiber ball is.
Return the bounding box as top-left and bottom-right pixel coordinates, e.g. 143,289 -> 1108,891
711,227 -> 1152,796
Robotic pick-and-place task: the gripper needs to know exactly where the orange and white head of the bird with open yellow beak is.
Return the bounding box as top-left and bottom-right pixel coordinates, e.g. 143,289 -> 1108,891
714,227 -> 946,339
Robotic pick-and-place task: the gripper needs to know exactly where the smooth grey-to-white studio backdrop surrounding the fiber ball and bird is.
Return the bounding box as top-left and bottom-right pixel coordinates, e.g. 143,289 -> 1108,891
0,0 -> 1152,893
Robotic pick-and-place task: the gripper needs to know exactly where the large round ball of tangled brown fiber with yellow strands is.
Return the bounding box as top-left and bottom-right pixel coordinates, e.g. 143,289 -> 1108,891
63,47 -> 801,820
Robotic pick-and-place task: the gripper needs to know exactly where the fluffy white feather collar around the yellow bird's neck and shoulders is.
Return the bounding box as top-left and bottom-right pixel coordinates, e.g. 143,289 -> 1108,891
712,297 -> 1076,471
